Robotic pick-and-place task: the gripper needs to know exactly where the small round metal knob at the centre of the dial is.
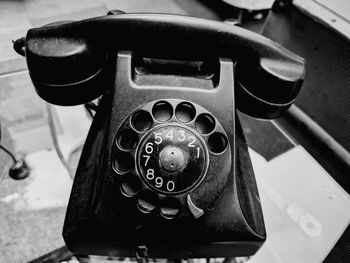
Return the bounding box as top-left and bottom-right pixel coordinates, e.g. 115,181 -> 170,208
159,146 -> 185,172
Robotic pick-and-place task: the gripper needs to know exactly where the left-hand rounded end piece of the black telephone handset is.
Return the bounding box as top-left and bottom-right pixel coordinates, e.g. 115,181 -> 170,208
25,21 -> 107,105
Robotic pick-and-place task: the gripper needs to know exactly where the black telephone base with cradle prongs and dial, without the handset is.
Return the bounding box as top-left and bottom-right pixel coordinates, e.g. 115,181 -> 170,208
63,53 -> 266,259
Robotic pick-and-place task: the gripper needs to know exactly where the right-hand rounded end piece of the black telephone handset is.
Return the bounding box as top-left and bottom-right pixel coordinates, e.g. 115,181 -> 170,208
235,47 -> 305,119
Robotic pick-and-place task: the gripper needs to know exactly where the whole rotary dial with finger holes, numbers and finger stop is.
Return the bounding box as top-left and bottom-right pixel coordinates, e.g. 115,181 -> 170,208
111,99 -> 231,219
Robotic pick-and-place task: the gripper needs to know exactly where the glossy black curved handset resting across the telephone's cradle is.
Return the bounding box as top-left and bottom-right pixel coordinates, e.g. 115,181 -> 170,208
25,13 -> 304,118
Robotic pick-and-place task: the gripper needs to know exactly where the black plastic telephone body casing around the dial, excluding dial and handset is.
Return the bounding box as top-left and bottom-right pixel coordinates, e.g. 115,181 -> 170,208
63,53 -> 266,258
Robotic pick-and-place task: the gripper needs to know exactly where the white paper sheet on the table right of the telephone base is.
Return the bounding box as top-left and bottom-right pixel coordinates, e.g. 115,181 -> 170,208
249,146 -> 350,263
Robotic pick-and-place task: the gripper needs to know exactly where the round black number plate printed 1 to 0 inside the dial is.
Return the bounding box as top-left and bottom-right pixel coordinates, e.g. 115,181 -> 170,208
137,125 -> 208,194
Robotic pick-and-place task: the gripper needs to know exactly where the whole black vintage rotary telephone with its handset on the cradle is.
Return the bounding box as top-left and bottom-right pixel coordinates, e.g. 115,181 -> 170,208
15,11 -> 304,258
